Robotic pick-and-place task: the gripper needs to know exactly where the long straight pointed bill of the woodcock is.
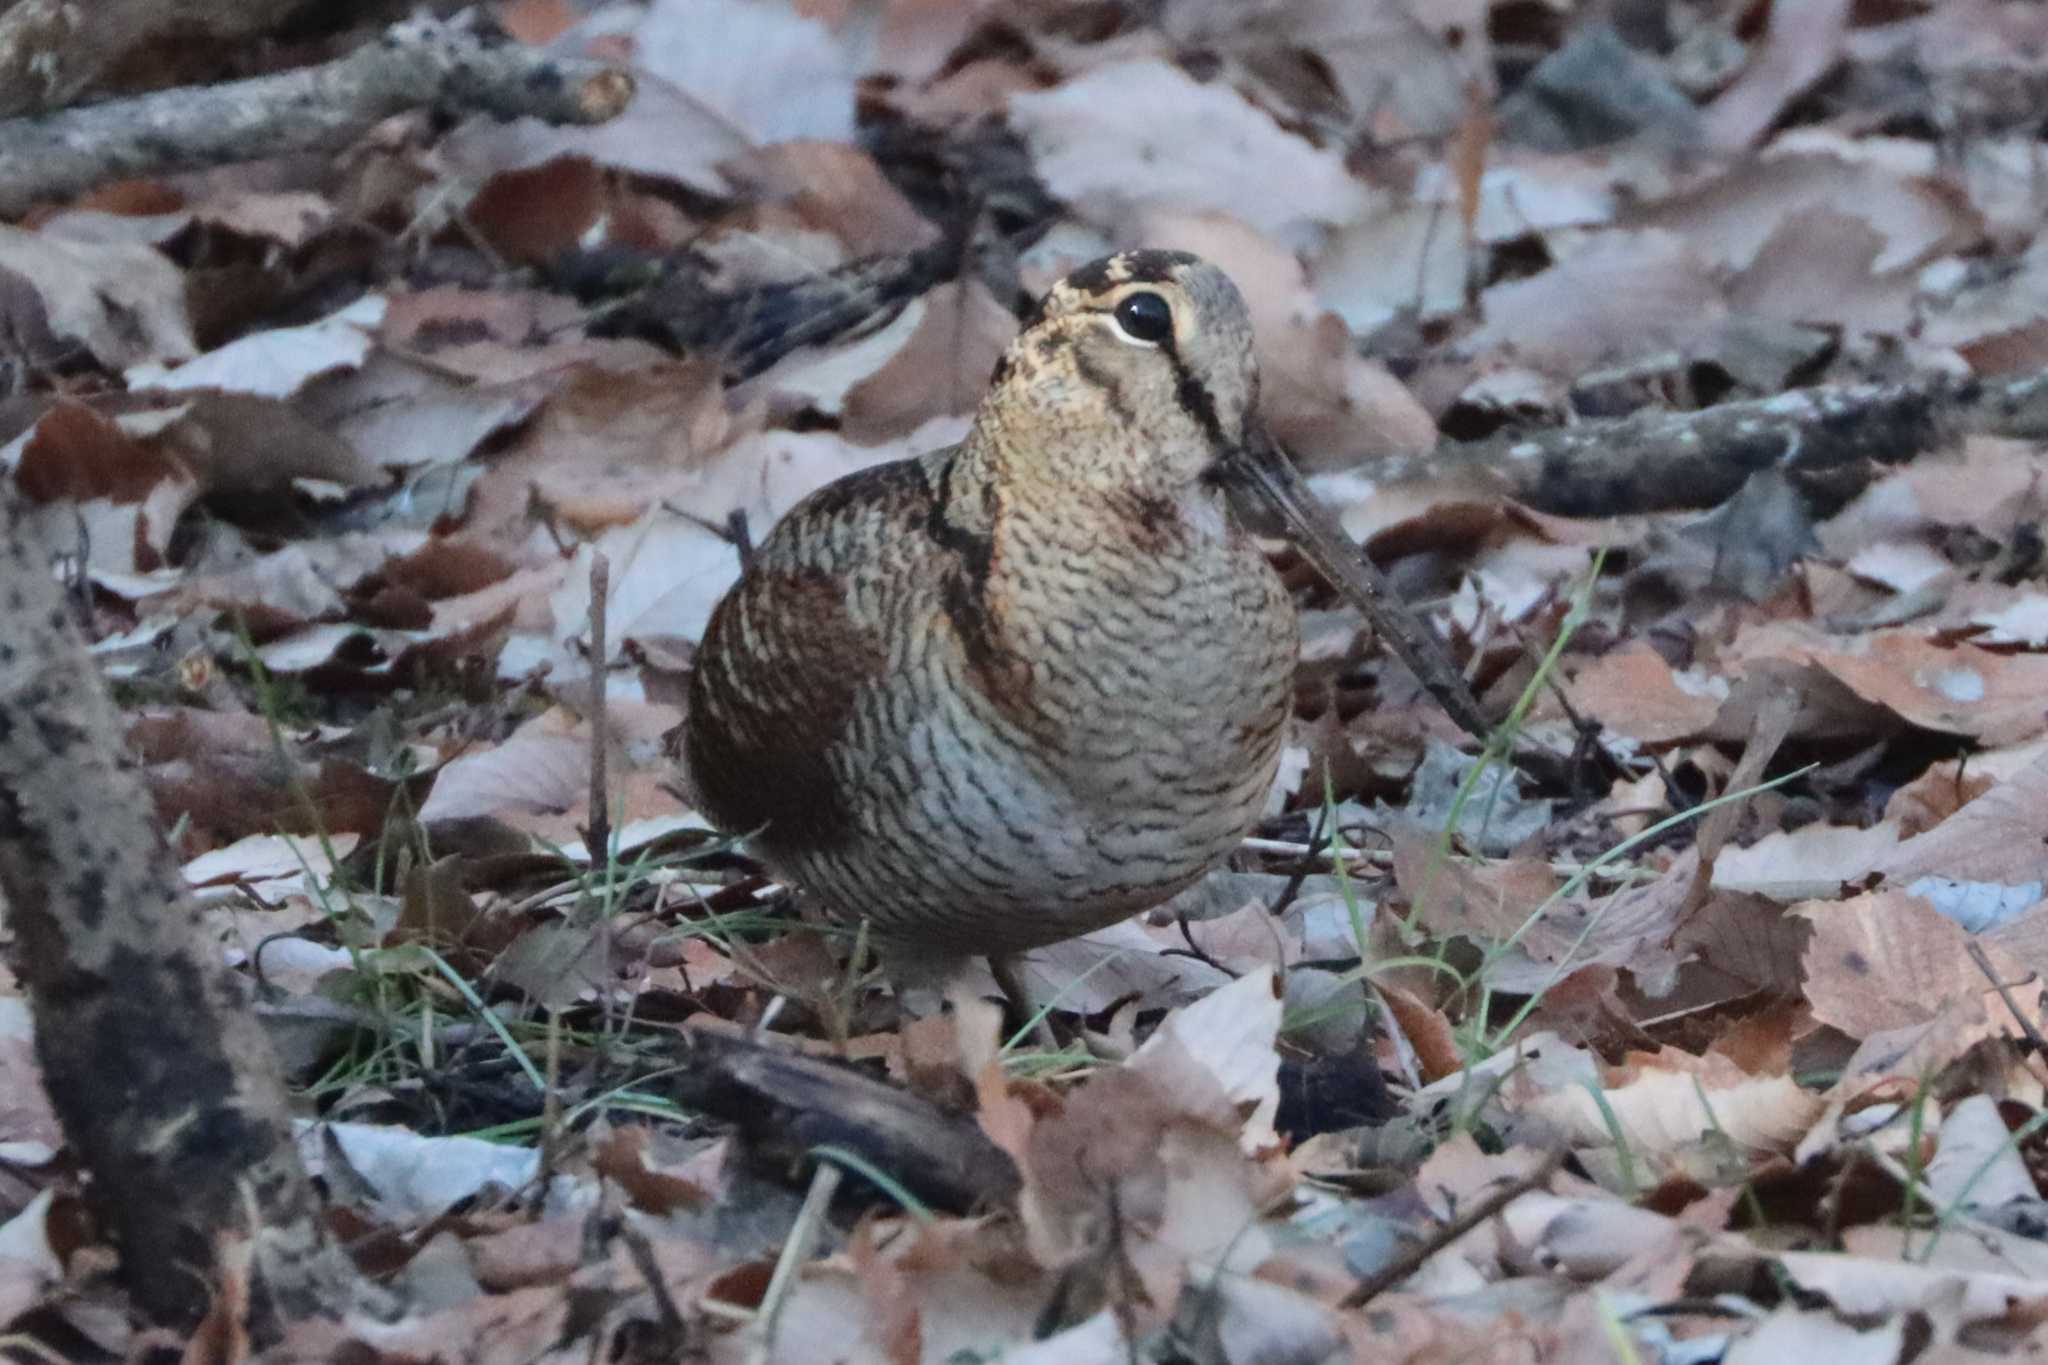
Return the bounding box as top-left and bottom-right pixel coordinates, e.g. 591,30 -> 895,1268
1223,422 -> 1491,741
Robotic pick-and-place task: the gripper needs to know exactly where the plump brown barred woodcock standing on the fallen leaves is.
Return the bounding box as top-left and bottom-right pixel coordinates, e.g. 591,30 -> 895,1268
684,252 -> 1356,956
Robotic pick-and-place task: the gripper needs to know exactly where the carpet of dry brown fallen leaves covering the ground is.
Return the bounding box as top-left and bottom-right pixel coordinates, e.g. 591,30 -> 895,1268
16,0 -> 2048,1365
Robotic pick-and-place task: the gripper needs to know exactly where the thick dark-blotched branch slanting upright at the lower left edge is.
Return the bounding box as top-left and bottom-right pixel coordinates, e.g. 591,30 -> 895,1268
0,479 -> 368,1338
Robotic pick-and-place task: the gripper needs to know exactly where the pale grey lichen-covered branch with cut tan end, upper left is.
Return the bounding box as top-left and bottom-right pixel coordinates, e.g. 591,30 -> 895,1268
0,13 -> 633,215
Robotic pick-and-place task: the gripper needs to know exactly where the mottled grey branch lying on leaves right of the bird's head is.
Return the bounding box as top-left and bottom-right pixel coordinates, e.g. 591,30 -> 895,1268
1370,375 -> 2048,518
